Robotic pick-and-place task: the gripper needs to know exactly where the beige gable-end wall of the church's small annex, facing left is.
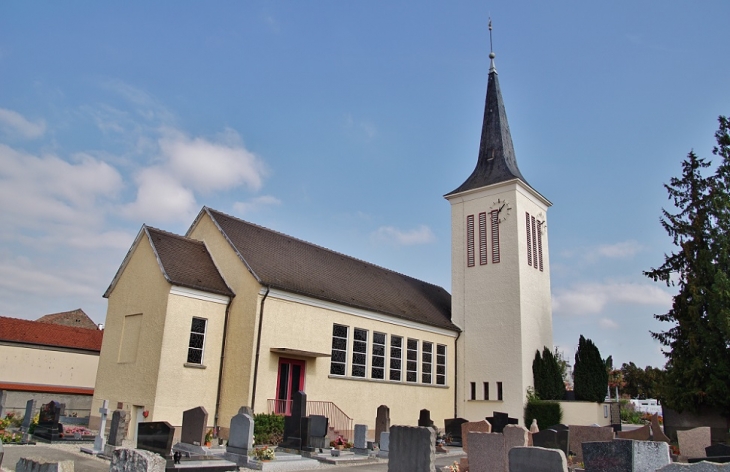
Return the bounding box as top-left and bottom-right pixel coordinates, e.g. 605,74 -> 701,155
90,233 -> 170,434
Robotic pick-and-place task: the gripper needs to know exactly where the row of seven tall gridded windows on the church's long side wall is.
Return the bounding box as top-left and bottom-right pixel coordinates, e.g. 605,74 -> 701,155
330,324 -> 446,385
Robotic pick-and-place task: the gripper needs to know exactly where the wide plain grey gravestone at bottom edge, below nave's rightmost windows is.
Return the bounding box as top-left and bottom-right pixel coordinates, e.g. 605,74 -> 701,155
388,426 -> 436,472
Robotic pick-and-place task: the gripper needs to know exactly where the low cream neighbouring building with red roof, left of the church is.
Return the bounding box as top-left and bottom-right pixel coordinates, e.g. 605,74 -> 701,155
0,317 -> 104,416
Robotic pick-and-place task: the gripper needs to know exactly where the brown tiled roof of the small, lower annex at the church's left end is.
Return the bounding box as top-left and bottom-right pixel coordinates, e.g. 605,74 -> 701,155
144,226 -> 234,297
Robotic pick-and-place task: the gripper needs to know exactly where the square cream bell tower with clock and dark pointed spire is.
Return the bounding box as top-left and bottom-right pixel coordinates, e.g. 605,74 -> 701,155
444,35 -> 553,426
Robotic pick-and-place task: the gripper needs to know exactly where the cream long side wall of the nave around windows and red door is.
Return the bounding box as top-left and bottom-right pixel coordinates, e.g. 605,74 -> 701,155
255,293 -> 456,429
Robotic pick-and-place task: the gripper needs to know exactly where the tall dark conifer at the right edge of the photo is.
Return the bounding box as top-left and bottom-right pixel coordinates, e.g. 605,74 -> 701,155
644,116 -> 730,414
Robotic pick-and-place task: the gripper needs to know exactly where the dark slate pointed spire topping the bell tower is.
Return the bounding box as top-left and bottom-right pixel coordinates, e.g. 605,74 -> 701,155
446,42 -> 529,196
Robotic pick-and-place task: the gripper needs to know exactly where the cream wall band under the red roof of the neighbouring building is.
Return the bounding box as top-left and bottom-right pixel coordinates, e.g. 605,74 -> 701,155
0,344 -> 99,388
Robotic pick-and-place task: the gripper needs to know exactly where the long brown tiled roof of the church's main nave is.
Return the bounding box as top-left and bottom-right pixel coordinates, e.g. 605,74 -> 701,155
204,208 -> 459,331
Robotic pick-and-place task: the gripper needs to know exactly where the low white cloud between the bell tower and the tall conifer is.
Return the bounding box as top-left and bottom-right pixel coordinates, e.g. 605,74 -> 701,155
553,283 -> 672,315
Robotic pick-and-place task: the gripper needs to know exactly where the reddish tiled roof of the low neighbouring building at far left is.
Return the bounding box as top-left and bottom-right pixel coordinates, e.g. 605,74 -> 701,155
0,316 -> 104,352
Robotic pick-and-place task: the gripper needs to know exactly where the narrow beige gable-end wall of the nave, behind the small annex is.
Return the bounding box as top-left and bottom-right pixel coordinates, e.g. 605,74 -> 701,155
188,214 -> 261,428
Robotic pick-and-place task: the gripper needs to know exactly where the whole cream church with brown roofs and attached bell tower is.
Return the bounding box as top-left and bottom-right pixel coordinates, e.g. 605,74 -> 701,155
90,49 -> 552,437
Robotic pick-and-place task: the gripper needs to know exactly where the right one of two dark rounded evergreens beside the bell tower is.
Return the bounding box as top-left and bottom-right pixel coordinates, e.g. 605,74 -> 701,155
573,335 -> 608,403
